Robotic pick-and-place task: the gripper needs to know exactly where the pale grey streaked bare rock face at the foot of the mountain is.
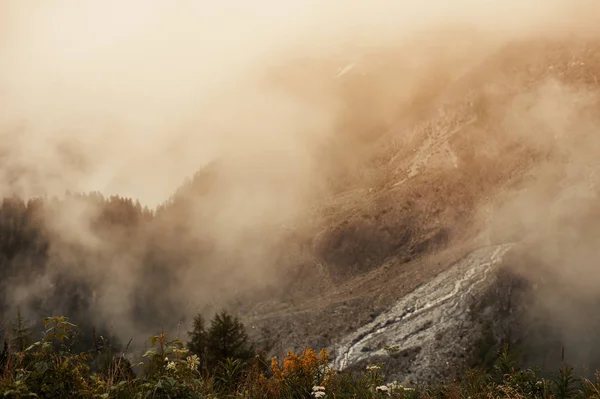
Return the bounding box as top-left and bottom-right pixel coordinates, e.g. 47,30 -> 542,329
335,244 -> 511,383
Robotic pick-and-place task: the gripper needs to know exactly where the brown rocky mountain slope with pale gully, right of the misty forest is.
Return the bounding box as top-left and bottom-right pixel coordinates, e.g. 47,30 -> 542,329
248,39 -> 600,381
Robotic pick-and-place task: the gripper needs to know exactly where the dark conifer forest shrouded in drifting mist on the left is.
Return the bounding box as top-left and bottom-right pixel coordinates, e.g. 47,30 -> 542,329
0,164 -> 288,349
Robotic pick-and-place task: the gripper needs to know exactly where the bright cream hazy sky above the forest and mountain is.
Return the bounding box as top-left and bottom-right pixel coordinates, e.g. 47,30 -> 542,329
0,0 -> 589,205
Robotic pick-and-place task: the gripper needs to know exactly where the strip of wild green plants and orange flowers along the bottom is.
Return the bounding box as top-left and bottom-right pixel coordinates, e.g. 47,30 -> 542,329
0,317 -> 600,399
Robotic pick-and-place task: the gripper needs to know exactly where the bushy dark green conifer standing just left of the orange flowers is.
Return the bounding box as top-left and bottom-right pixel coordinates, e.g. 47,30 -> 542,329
206,311 -> 253,366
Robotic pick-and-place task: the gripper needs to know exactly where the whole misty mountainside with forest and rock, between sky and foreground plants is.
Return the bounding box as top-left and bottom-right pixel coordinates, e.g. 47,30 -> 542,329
0,34 -> 600,381
